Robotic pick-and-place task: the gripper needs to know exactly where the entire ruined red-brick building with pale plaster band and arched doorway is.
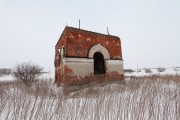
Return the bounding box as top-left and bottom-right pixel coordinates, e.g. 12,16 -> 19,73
54,26 -> 124,85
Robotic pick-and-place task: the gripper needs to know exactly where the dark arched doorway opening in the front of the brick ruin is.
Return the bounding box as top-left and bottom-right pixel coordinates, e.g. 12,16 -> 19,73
93,52 -> 105,74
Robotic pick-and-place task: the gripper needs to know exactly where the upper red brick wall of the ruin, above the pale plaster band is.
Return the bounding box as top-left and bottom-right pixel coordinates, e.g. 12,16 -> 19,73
56,27 -> 122,59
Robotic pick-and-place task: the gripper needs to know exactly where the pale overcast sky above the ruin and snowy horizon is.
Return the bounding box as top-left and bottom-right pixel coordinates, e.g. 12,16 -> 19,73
0,0 -> 180,71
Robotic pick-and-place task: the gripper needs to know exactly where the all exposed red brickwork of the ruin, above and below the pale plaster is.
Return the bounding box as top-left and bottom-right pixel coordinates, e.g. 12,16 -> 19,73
54,27 -> 124,85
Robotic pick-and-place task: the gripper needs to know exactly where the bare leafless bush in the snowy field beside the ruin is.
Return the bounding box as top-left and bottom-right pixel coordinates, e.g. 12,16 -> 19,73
13,62 -> 43,86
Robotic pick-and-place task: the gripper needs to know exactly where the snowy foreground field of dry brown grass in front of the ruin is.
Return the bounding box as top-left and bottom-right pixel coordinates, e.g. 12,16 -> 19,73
0,75 -> 180,120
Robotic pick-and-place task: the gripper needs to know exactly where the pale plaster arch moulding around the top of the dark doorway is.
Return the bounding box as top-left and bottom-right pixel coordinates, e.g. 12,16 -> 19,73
88,44 -> 110,59
